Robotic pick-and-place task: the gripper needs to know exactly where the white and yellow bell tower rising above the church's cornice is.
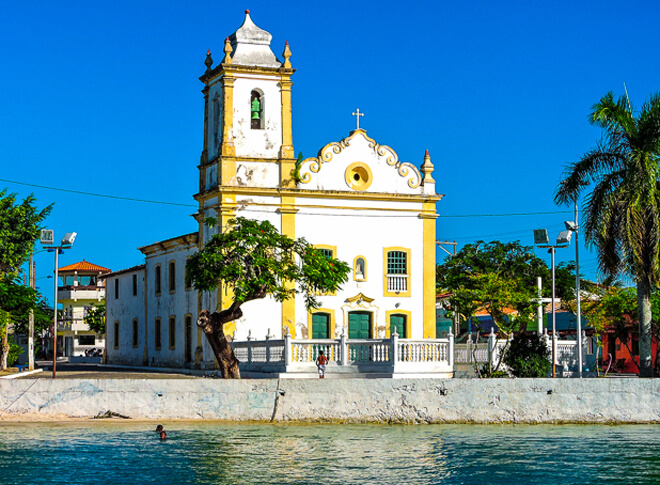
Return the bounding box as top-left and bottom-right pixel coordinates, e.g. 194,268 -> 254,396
196,10 -> 295,192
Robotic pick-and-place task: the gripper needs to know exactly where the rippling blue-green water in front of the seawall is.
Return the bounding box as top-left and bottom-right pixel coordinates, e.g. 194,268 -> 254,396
0,421 -> 660,485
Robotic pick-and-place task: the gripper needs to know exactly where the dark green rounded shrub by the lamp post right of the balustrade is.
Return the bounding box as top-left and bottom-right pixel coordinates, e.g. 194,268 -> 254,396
504,333 -> 552,377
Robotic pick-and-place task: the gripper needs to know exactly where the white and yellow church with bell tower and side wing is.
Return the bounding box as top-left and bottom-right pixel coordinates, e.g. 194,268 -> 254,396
106,11 -> 442,368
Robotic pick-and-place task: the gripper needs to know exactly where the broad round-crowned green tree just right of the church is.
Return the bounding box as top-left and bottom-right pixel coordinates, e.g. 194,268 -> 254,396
437,241 -> 547,371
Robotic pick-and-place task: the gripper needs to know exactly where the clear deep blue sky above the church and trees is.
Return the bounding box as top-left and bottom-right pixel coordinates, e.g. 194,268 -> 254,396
0,0 -> 660,302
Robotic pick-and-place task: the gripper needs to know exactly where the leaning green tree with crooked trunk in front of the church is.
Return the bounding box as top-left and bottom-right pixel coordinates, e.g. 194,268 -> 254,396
186,217 -> 350,378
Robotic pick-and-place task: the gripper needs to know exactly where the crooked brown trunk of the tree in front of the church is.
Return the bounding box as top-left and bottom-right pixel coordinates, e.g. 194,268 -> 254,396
197,305 -> 243,379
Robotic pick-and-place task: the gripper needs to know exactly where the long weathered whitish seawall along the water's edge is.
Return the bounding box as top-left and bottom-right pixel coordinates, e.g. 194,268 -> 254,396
0,379 -> 660,423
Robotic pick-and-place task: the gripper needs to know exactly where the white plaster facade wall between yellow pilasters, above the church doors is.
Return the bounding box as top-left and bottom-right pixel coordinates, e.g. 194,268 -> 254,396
296,199 -> 423,338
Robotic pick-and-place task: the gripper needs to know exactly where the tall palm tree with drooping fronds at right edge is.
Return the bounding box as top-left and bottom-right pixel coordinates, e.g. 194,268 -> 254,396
555,92 -> 660,377
